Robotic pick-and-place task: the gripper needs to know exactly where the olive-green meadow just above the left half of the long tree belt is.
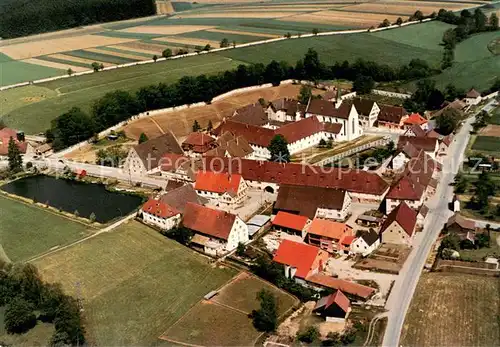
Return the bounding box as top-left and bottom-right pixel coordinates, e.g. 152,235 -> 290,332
1,54 -> 240,134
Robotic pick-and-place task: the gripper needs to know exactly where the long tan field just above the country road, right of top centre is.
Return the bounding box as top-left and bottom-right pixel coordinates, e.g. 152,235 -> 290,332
286,10 -> 398,26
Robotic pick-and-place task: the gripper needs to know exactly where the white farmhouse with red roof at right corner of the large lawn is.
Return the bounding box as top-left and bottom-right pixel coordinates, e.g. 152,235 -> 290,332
182,203 -> 248,256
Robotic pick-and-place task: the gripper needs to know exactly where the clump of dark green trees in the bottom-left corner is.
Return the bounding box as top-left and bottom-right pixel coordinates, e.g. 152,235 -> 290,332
0,264 -> 85,346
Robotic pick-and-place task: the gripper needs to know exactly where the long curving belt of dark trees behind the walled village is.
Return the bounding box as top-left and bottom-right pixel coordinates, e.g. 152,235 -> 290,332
46,49 -> 438,150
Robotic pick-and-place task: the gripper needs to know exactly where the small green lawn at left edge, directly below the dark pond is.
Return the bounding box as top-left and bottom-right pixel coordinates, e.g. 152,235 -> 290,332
0,195 -> 90,262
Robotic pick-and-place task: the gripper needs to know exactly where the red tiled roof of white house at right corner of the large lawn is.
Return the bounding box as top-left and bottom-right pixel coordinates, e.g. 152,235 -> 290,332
182,202 -> 236,240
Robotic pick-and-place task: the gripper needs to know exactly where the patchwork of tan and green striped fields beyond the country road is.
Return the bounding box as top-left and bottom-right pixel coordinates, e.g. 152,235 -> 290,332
0,0 -> 477,85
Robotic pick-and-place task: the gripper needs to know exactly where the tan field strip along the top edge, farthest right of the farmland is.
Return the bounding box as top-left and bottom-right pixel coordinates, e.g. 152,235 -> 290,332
345,1 -> 471,15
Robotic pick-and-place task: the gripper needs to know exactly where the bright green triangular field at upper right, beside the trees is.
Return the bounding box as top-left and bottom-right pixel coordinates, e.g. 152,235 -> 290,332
370,21 -> 454,52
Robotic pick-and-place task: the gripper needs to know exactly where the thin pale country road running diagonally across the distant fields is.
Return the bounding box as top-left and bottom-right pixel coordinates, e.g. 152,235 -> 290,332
0,18 -> 432,91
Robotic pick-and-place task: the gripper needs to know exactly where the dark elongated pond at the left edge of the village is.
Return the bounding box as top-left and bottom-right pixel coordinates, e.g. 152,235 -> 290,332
0,175 -> 142,223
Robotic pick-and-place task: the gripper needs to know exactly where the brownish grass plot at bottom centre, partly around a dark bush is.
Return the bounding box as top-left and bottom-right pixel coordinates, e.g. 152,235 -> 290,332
161,273 -> 298,346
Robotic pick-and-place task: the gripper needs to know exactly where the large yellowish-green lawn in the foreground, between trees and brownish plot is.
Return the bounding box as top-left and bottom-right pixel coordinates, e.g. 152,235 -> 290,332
35,222 -> 236,346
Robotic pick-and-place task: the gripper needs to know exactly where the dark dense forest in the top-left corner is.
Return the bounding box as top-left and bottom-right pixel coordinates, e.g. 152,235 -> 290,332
0,0 -> 156,39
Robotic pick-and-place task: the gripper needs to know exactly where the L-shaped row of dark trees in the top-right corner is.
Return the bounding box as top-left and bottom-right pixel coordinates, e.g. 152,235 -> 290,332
436,8 -> 498,69
